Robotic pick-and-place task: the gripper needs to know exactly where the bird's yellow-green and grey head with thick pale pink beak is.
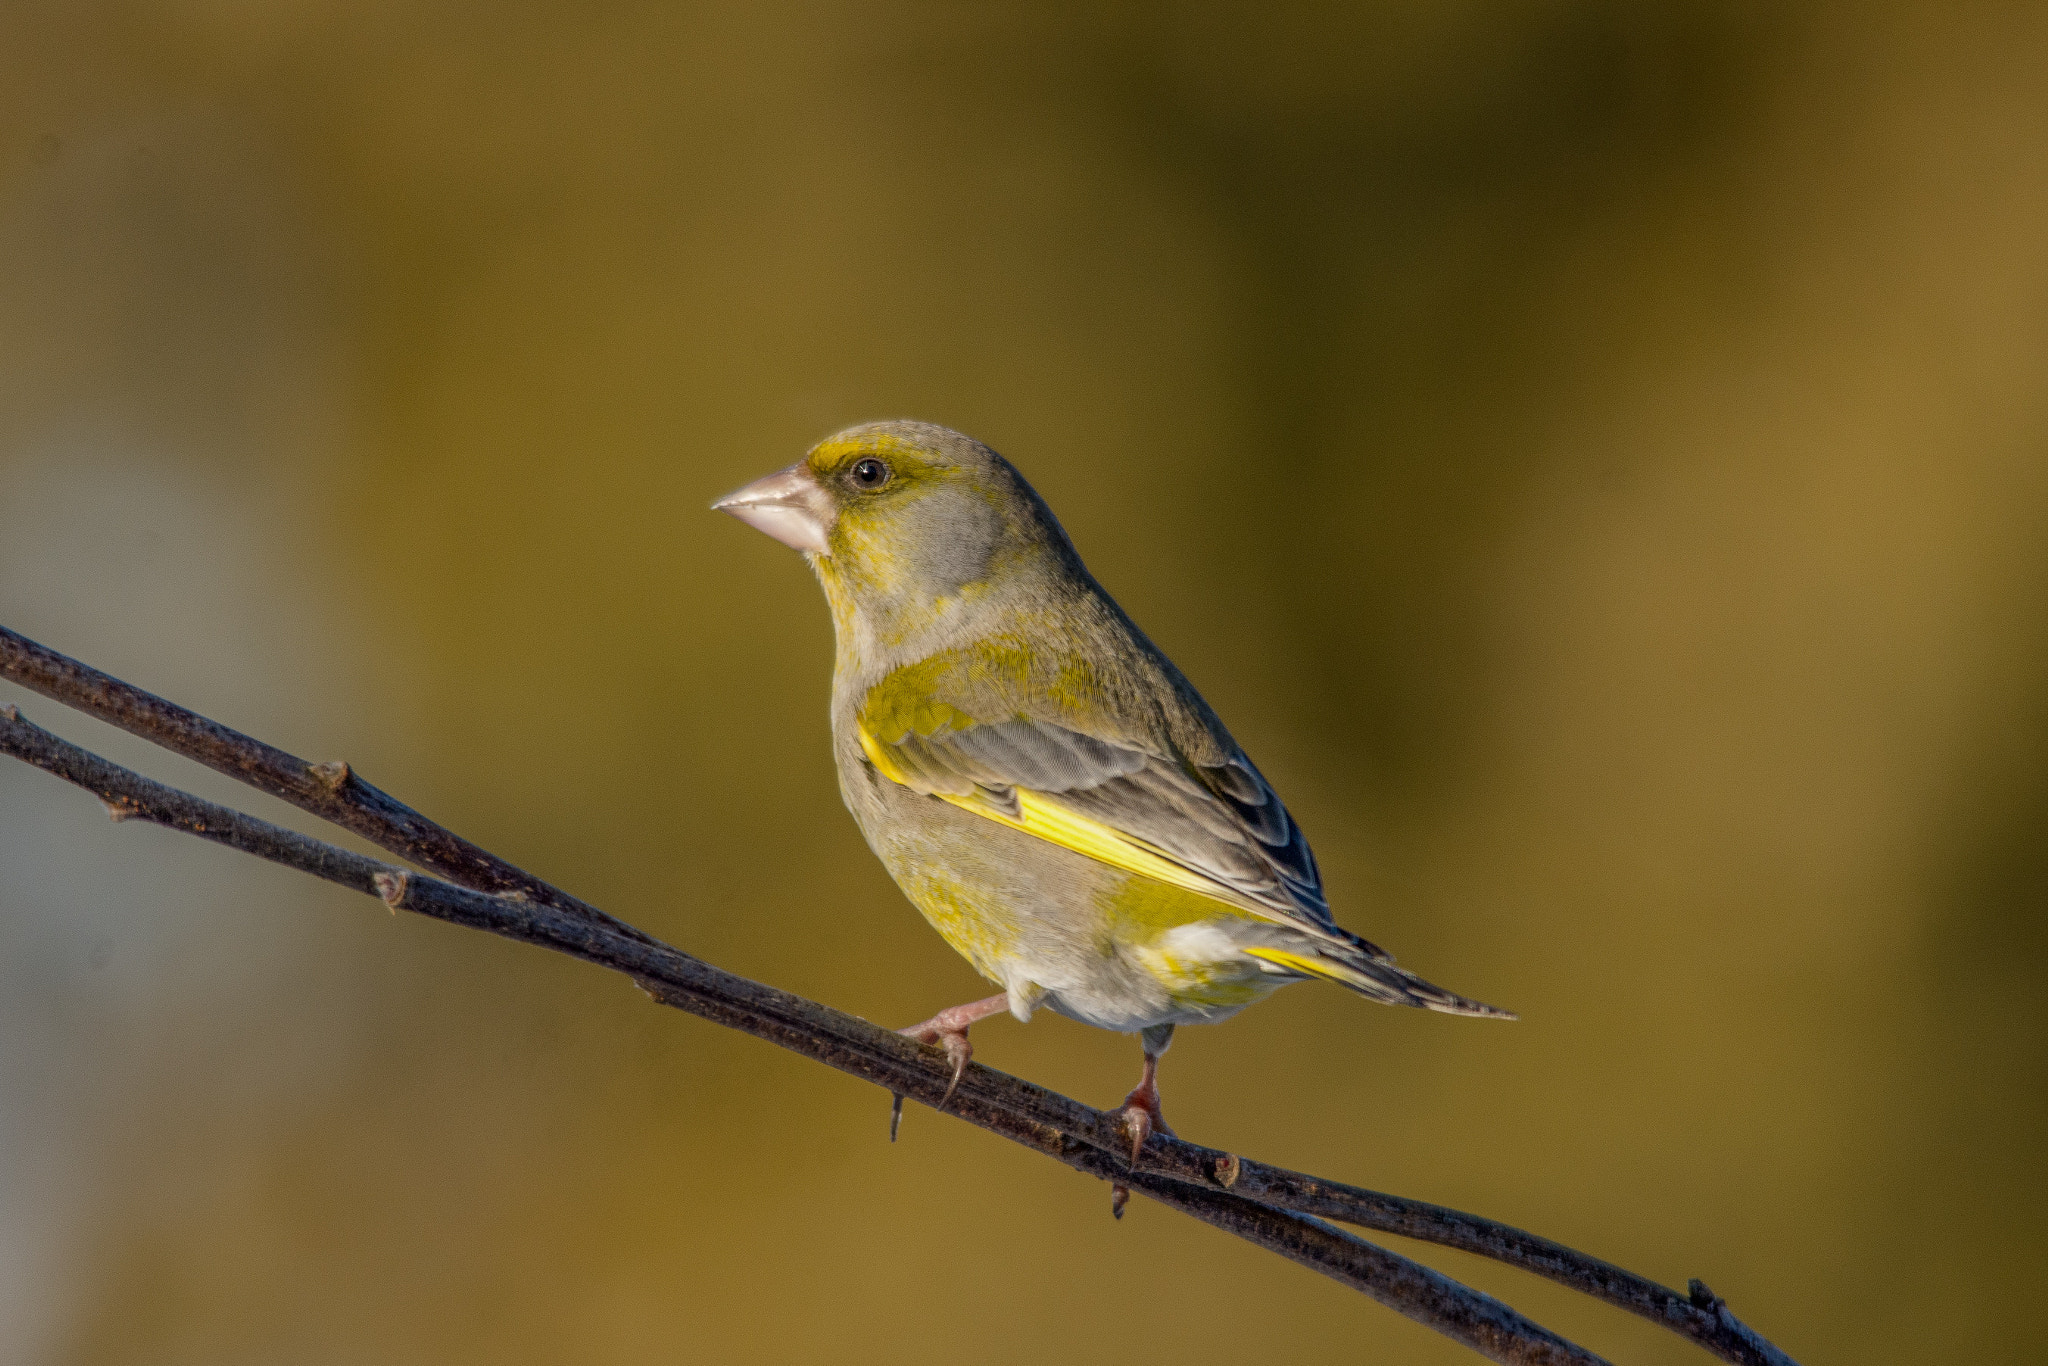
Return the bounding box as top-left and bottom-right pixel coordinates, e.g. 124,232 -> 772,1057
711,422 -> 1077,634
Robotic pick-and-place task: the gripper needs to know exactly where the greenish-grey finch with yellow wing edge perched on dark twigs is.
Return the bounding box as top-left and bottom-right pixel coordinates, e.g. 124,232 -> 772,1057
713,420 -> 1516,1214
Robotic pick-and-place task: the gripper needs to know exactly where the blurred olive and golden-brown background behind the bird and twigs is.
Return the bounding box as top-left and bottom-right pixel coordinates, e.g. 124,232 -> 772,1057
0,0 -> 2048,1364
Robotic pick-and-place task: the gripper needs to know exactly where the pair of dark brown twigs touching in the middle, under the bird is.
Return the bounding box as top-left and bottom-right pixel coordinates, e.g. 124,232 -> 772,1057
0,627 -> 1794,1366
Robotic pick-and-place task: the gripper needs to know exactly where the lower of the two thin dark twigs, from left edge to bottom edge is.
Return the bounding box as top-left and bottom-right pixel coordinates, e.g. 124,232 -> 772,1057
0,707 -> 1606,1366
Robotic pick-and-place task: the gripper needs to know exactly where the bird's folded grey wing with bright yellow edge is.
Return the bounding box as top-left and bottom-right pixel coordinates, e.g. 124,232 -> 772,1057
856,675 -> 1378,956
